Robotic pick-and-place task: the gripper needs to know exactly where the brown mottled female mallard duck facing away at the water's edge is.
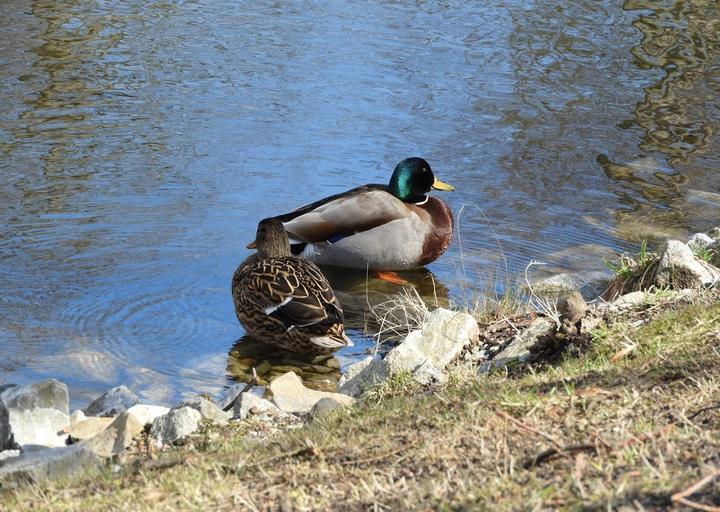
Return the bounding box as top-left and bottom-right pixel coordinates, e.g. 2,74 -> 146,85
232,219 -> 352,354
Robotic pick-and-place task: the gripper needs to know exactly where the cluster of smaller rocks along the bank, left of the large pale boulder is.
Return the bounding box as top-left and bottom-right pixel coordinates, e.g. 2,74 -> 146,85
0,372 -> 354,487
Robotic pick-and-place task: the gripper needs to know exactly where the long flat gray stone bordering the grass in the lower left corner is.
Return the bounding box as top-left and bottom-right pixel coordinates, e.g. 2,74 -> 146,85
0,444 -> 99,489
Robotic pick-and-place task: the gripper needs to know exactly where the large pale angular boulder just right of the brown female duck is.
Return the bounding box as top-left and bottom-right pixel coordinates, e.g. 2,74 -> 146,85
385,308 -> 480,374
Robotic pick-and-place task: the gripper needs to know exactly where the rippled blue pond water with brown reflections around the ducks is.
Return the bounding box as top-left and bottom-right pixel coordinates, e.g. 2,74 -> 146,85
0,0 -> 720,406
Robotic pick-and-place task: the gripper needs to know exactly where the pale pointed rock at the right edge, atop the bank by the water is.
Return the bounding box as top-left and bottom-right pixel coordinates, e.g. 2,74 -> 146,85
653,240 -> 720,289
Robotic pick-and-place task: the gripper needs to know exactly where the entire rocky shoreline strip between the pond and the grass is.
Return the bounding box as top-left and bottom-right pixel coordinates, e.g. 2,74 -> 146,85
0,228 -> 720,489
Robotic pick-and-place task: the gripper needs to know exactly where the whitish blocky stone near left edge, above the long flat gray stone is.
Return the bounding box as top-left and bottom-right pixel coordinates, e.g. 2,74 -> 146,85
8,408 -> 70,446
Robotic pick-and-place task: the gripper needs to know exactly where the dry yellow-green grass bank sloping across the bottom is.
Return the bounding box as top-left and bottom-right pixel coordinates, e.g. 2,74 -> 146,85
5,303 -> 720,511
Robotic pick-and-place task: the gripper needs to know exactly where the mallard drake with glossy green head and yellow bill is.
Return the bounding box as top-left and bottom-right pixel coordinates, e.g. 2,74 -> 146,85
248,157 -> 453,270
